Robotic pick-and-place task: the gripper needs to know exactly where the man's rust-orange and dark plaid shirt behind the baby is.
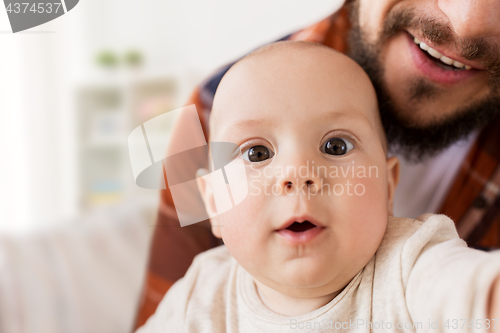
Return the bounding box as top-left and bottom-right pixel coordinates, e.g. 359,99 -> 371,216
136,7 -> 500,327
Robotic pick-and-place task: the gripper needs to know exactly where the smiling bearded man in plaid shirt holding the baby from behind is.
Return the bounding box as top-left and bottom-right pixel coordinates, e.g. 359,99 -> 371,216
132,0 -> 500,326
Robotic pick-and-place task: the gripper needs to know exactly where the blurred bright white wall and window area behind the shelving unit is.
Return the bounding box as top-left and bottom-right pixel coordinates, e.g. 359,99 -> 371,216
0,0 -> 342,232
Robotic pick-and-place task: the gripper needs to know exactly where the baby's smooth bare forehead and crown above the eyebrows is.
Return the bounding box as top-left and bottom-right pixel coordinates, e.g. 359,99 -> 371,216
210,42 -> 383,150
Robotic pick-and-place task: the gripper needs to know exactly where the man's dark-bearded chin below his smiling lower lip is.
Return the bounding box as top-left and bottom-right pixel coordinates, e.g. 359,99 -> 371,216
378,71 -> 500,163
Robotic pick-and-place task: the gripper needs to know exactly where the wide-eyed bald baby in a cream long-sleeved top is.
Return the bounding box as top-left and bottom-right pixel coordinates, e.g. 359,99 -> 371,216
139,42 -> 500,333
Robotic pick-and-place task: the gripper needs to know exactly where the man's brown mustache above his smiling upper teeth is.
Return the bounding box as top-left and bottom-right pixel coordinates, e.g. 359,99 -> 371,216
379,9 -> 500,87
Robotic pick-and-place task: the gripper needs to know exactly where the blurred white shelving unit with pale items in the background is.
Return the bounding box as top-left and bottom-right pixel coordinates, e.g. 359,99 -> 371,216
76,76 -> 178,210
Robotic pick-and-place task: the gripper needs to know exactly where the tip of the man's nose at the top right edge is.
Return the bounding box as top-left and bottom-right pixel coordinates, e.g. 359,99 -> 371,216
438,0 -> 500,38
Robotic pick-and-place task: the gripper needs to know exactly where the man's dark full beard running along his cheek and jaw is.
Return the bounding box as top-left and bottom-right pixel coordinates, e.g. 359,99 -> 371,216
349,1 -> 500,163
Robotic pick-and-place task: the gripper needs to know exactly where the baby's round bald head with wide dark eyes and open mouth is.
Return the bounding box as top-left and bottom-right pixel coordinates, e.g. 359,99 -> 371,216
195,42 -> 398,312
